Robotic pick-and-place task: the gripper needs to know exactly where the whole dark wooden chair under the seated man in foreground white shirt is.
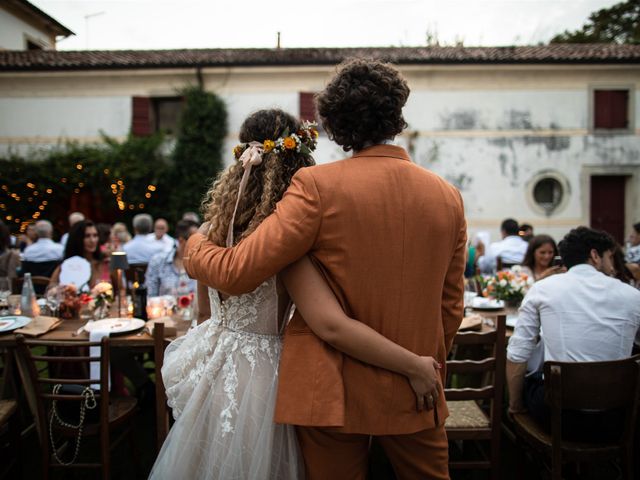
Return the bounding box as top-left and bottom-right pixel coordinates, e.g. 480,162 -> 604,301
513,355 -> 640,480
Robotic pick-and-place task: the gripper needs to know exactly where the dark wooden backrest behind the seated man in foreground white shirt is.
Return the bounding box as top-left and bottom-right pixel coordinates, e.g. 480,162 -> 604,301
544,355 -> 640,444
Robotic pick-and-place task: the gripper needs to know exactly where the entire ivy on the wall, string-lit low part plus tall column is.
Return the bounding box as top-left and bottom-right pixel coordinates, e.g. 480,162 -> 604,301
0,87 -> 227,236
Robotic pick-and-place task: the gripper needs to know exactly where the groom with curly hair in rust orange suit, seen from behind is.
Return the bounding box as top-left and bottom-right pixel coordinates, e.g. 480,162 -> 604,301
184,60 -> 466,480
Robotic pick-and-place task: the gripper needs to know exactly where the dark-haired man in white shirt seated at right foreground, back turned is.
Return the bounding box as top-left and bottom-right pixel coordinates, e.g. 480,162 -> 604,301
507,227 -> 640,423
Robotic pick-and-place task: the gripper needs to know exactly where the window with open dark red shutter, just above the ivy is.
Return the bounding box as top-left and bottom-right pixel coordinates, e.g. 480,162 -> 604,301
131,97 -> 184,137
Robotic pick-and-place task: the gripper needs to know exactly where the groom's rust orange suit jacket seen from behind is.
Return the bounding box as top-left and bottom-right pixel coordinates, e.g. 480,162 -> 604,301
185,145 -> 466,435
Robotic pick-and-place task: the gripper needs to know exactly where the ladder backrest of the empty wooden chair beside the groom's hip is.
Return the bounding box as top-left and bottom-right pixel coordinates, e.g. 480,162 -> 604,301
445,315 -> 506,428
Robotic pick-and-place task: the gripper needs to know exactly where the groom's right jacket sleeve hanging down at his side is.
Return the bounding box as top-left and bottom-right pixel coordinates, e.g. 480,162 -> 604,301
442,192 -> 467,355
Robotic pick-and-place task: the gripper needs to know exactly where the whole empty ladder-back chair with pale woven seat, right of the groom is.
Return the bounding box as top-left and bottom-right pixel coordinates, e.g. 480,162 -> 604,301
445,315 -> 506,479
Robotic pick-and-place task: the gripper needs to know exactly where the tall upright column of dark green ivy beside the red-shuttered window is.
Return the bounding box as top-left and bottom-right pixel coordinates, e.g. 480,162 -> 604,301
169,87 -> 227,218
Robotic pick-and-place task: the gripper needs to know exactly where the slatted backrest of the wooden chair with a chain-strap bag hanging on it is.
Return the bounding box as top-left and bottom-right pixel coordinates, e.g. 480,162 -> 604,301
16,335 -> 109,457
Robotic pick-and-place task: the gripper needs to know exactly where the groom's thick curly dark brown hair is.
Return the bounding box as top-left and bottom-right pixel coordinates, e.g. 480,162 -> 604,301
316,59 -> 410,152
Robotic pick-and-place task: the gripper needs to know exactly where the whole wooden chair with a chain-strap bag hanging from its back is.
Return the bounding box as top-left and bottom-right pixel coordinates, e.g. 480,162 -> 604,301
16,335 -> 137,480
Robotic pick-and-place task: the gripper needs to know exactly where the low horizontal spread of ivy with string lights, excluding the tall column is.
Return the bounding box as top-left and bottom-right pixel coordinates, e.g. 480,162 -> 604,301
0,134 -> 169,232
